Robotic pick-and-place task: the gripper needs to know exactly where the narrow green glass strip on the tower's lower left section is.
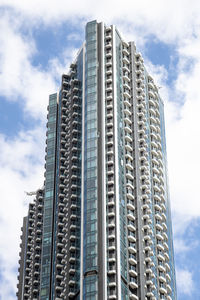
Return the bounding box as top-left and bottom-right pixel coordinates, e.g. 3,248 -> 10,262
40,94 -> 57,300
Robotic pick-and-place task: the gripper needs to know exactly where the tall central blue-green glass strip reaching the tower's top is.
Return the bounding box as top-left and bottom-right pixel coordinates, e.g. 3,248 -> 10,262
83,22 -> 98,300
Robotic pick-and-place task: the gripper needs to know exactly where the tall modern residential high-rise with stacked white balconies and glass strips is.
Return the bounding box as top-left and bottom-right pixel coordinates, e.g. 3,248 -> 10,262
17,21 -> 176,300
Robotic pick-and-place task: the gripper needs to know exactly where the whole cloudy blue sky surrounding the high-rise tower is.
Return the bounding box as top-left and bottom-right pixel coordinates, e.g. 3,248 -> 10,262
0,0 -> 200,300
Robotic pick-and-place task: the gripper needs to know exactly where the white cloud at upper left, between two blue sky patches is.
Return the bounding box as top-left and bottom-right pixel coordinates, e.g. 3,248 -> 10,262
0,16 -> 57,118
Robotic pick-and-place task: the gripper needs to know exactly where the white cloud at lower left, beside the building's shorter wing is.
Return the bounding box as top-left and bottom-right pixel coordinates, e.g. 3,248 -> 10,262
0,128 -> 45,299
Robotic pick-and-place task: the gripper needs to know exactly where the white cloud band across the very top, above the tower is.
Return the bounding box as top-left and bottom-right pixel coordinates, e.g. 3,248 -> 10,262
1,0 -> 200,42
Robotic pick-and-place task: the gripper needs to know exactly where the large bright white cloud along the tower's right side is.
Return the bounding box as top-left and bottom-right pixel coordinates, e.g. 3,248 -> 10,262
167,56 -> 200,217
